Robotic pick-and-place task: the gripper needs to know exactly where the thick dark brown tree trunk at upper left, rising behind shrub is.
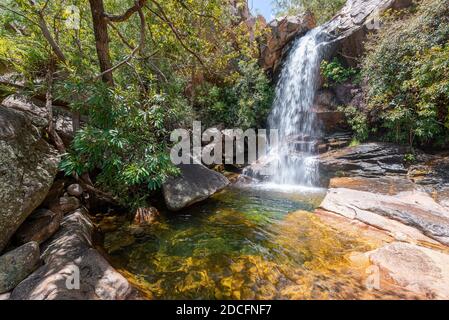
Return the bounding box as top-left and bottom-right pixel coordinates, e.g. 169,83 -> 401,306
89,0 -> 114,86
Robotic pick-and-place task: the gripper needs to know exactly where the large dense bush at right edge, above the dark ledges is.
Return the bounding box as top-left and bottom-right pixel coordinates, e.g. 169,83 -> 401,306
363,0 -> 449,145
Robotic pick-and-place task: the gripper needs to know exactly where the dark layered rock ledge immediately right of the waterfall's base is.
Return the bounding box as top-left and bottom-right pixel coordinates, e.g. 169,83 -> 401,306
319,142 -> 409,178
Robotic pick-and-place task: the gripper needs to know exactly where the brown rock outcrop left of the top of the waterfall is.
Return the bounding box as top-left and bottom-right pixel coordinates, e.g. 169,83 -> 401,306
260,12 -> 316,74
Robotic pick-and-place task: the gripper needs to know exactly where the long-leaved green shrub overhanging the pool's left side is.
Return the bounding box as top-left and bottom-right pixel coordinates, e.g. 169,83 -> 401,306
61,84 -> 186,207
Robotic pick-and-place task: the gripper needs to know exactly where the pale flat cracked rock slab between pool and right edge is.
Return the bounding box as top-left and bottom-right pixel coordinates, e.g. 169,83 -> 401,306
320,188 -> 449,245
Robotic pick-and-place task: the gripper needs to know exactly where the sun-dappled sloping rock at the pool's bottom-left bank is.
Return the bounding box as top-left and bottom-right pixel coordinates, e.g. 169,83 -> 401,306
10,210 -> 132,300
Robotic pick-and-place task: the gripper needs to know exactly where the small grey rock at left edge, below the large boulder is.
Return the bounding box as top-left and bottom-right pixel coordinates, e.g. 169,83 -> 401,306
0,242 -> 40,293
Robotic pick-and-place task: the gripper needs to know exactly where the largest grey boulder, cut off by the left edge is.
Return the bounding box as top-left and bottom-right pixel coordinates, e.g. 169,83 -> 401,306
0,106 -> 59,252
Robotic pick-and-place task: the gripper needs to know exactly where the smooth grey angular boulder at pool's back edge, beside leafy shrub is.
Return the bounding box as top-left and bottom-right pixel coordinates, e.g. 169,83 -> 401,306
162,163 -> 229,211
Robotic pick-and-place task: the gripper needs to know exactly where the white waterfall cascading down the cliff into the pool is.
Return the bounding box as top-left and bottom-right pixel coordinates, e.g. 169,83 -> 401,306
268,28 -> 324,186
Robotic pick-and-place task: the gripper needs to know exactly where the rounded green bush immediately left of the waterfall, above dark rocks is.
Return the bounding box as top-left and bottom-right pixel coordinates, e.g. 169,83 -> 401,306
197,60 -> 274,129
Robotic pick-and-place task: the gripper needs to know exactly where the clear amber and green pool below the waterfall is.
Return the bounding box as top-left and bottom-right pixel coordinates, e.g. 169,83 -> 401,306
104,186 -> 396,299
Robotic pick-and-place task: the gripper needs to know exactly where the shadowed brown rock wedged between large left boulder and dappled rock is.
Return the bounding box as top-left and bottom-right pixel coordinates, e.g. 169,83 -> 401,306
14,209 -> 63,244
